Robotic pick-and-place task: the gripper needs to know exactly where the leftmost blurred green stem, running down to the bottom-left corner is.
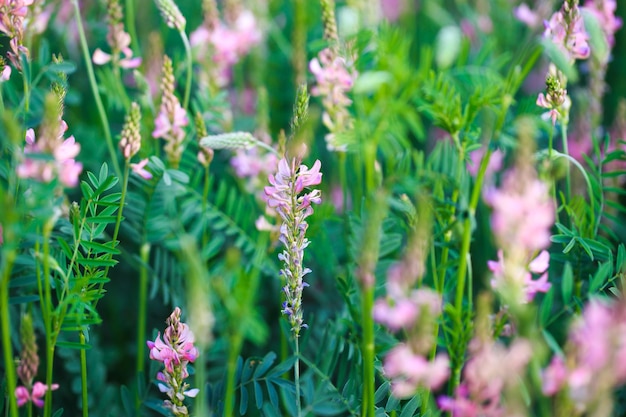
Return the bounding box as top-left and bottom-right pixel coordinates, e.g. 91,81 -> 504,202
0,250 -> 18,417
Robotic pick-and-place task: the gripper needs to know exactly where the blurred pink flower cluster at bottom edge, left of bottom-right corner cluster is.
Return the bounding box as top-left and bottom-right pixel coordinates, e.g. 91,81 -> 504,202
437,338 -> 532,417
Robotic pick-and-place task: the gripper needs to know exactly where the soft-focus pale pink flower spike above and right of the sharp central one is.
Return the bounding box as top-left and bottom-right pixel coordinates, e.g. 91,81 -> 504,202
309,48 -> 357,151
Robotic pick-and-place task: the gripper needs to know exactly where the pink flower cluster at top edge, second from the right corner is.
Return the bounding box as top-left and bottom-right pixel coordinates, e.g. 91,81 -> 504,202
544,0 -> 591,62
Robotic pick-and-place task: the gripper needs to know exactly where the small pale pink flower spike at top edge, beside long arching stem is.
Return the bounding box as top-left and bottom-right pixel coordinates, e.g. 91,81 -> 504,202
93,0 -> 141,68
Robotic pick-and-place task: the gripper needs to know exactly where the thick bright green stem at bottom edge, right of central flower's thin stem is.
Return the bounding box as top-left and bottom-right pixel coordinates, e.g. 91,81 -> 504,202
361,285 -> 375,417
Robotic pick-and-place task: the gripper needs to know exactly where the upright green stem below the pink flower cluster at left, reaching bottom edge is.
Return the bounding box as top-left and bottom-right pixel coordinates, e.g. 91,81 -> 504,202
42,221 -> 56,417
